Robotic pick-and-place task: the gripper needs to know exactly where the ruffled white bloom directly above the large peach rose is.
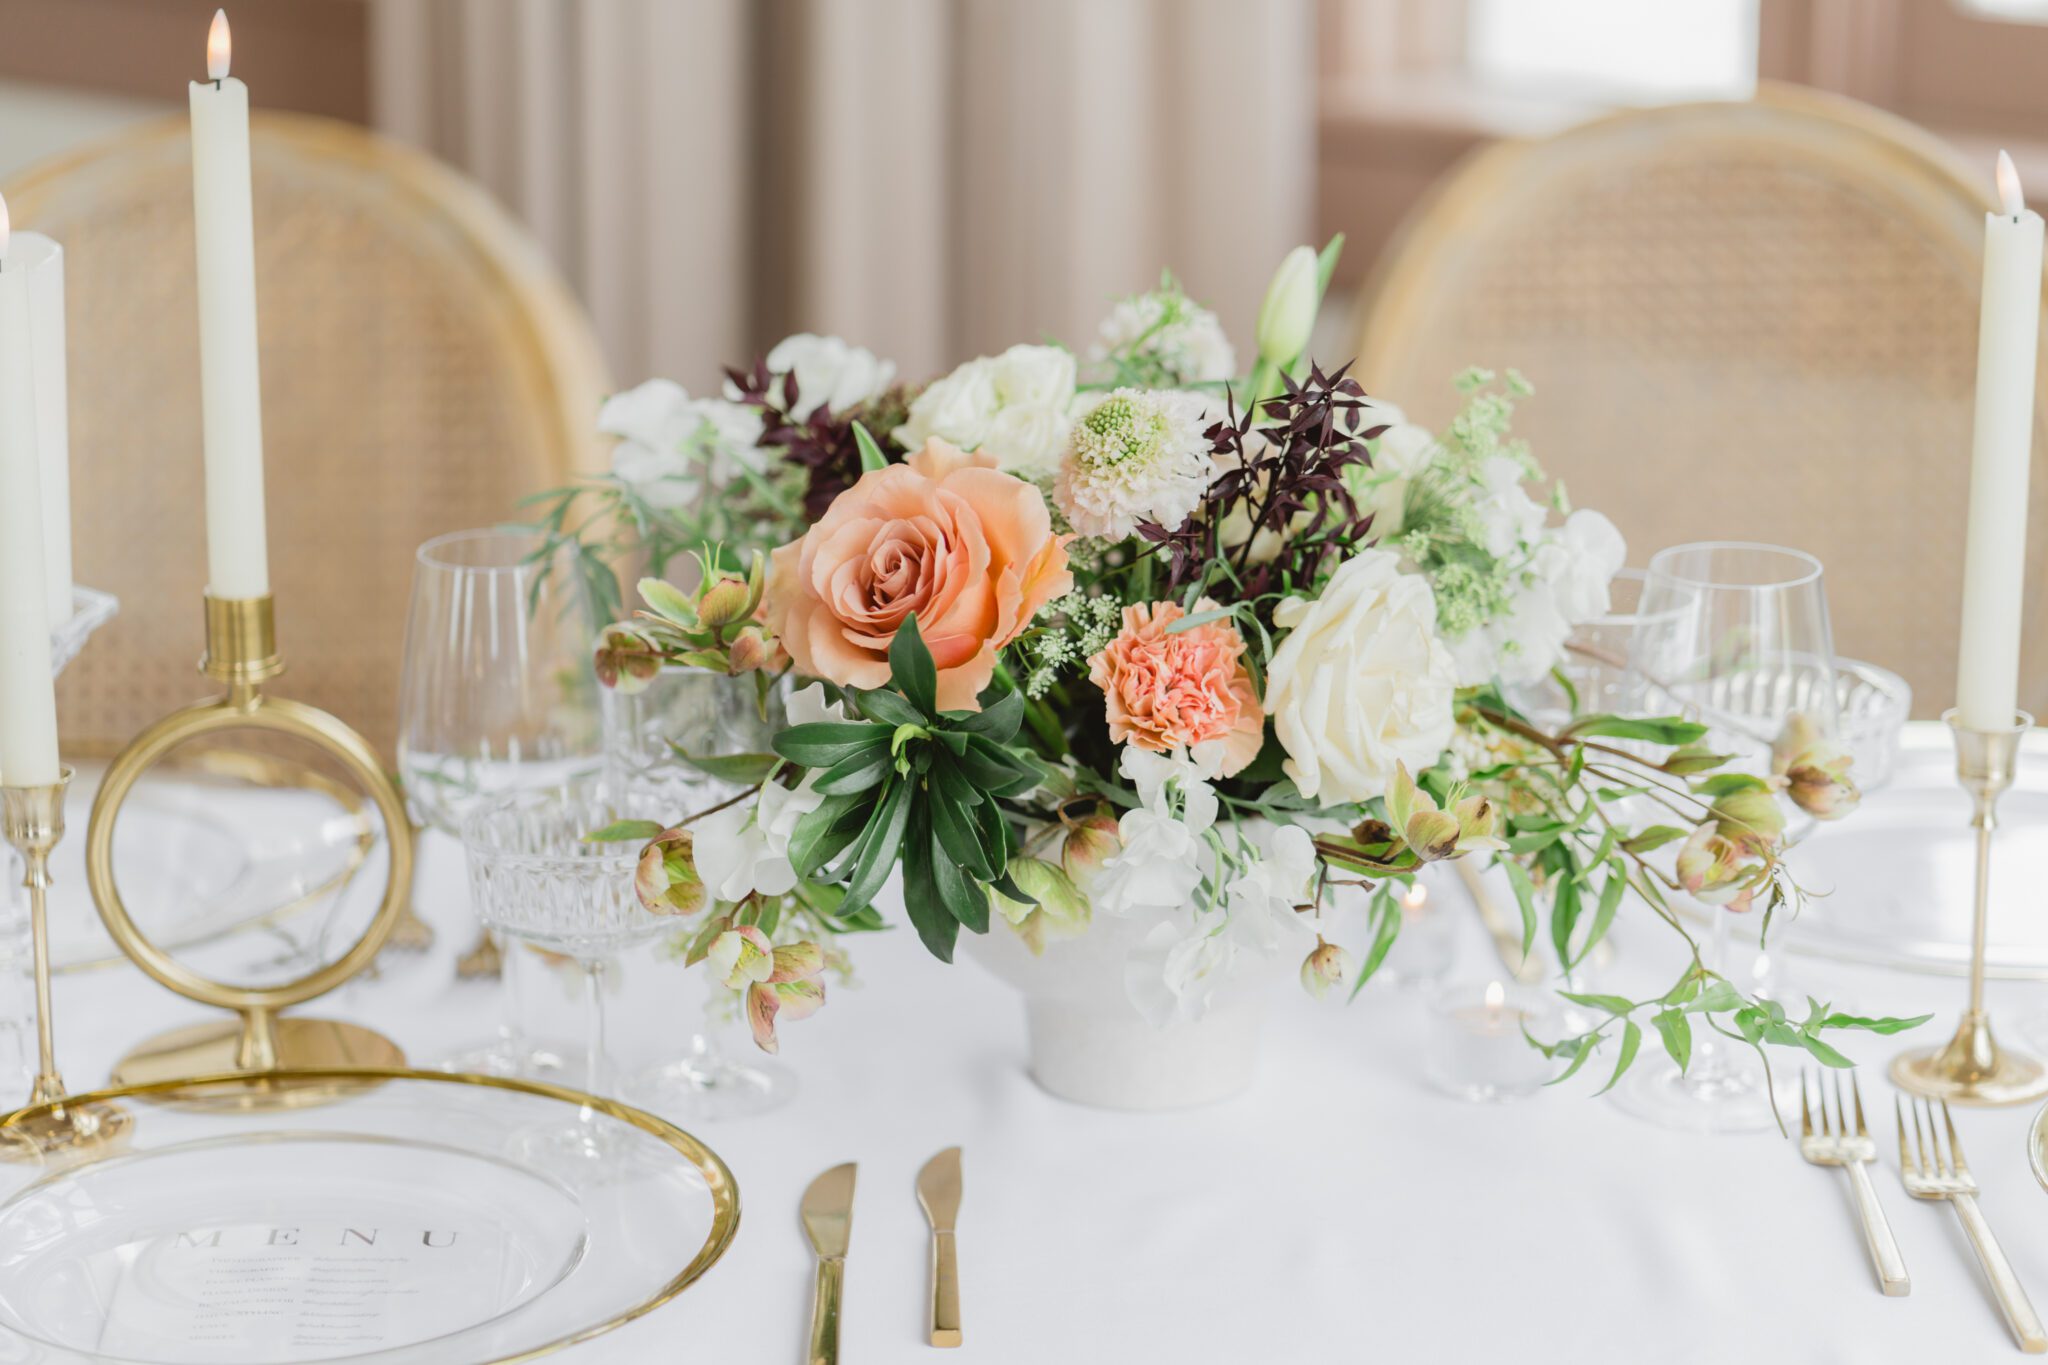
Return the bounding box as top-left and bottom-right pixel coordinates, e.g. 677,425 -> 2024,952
893,346 -> 1075,479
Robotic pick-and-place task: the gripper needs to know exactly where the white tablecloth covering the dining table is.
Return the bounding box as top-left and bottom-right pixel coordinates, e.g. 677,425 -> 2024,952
32,834 -> 2048,1365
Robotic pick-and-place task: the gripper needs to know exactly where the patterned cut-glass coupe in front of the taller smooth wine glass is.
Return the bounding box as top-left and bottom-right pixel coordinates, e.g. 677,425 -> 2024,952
463,784 -> 674,1156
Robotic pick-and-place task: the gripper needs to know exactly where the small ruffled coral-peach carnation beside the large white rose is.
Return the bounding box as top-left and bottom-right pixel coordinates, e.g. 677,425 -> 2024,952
1087,598 -> 1266,778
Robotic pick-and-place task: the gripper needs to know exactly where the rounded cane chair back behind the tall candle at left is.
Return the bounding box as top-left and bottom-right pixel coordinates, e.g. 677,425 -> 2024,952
8,117 -> 604,751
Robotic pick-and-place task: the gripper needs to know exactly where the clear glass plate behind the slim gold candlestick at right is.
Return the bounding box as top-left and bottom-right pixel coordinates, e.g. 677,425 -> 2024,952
1681,720 -> 2048,980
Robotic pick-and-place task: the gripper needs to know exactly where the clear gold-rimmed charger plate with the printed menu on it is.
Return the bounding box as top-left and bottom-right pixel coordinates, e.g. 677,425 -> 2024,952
0,1070 -> 739,1365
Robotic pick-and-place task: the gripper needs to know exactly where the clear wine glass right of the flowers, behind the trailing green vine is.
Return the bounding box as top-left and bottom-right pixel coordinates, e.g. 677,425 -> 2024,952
1616,542 -> 1839,1132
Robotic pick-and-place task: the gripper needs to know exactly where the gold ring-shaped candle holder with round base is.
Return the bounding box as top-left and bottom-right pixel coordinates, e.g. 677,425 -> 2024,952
86,596 -> 412,1085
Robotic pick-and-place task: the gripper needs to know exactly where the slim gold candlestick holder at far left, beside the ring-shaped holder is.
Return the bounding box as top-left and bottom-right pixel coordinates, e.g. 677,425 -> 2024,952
0,767 -> 129,1158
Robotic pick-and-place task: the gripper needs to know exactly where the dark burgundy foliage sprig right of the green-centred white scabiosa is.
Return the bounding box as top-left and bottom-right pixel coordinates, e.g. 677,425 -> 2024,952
1139,364 -> 1386,602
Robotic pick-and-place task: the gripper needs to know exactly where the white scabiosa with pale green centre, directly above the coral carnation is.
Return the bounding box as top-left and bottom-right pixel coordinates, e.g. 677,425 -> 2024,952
1053,389 -> 1217,540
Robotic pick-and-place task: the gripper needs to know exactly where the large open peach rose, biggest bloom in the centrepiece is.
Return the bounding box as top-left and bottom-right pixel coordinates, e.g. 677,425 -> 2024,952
766,438 -> 1073,710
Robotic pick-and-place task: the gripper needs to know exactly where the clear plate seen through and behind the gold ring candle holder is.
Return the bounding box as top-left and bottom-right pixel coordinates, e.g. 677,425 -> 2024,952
29,755 -> 383,978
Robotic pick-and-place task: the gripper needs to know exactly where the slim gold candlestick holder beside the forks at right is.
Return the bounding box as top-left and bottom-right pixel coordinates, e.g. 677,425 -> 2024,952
1892,710 -> 2048,1107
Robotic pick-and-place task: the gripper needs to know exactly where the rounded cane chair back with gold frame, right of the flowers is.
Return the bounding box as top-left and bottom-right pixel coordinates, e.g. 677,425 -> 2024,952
1364,96 -> 2048,716
